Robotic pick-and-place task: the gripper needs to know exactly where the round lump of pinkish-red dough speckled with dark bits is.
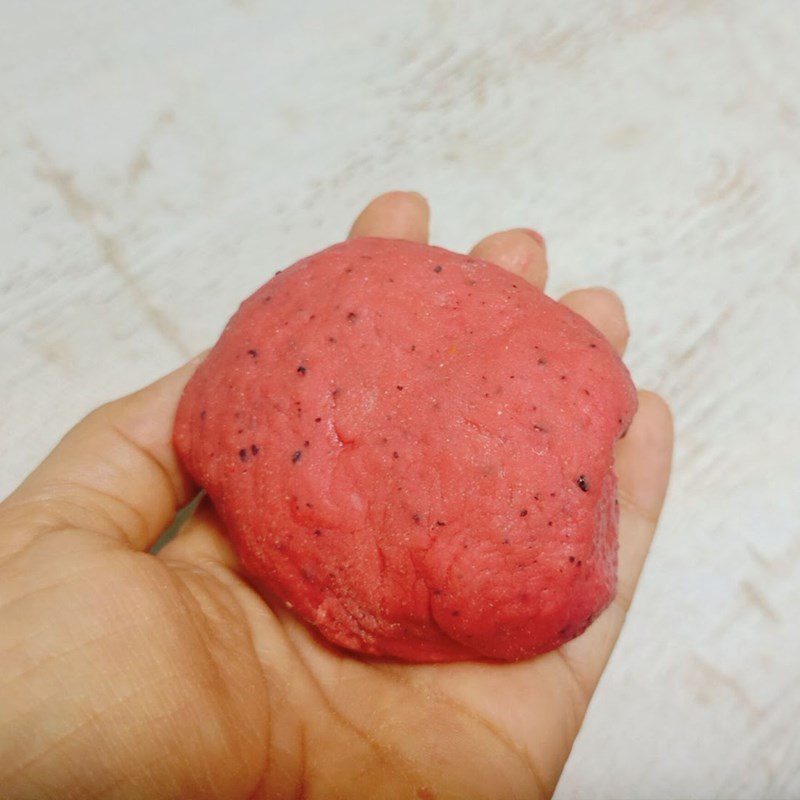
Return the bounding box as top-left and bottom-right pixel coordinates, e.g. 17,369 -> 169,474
175,239 -> 636,661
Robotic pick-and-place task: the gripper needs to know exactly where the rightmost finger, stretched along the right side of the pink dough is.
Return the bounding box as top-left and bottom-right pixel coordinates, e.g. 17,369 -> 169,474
562,392 -> 673,672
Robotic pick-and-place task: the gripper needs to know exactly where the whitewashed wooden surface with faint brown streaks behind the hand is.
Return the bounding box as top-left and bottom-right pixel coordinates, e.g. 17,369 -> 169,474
0,0 -> 800,800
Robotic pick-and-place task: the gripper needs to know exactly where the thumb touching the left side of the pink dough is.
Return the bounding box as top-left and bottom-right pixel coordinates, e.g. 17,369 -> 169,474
0,356 -> 204,550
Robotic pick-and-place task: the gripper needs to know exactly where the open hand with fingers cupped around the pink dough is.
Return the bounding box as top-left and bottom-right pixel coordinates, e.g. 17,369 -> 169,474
0,193 -> 672,800
